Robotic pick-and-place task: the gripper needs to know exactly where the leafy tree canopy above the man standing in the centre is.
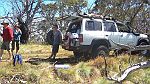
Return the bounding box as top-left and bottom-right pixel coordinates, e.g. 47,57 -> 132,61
41,0 -> 87,28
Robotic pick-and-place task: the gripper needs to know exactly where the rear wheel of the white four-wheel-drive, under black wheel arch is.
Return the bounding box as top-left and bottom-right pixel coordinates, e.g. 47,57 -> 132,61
92,46 -> 109,57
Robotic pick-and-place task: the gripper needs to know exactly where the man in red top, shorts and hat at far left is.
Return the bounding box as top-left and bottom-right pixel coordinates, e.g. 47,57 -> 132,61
0,21 -> 13,60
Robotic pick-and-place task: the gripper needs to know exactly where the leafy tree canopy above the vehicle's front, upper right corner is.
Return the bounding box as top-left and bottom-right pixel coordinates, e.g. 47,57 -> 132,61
92,0 -> 150,32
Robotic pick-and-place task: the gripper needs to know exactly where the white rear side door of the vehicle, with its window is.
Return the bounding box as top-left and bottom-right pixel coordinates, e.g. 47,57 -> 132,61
103,21 -> 119,48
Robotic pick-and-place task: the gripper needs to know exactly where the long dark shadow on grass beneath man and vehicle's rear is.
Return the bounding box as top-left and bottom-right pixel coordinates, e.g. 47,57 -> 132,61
25,56 -> 94,65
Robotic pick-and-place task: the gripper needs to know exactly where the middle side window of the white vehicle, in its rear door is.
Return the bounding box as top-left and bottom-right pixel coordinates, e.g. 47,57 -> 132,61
104,22 -> 117,32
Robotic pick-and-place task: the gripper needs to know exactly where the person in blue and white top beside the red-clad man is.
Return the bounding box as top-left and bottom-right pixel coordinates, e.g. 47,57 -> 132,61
11,25 -> 22,55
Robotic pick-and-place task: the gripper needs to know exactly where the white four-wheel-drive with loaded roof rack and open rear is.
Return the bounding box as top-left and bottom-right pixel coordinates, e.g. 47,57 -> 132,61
62,16 -> 149,56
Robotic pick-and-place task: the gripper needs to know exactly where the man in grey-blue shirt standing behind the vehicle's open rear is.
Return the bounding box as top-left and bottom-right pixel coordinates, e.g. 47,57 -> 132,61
49,24 -> 62,59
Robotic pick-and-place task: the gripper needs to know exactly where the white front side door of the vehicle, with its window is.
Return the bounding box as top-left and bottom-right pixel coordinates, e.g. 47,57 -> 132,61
117,23 -> 137,46
